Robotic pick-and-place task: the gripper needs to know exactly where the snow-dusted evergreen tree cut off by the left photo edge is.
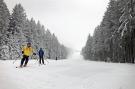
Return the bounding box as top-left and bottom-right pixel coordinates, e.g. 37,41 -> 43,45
0,0 -> 10,59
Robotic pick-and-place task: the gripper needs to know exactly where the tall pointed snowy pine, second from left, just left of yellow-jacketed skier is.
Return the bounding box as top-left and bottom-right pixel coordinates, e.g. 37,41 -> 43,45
9,4 -> 26,59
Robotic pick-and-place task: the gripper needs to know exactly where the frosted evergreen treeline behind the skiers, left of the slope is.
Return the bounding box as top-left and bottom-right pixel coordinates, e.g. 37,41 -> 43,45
0,0 -> 68,59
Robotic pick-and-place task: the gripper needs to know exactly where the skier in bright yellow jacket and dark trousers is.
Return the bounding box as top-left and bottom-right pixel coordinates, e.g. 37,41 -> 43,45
20,43 -> 34,67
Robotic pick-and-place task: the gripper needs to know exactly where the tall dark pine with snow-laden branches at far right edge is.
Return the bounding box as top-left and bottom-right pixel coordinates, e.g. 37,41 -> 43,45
118,0 -> 135,63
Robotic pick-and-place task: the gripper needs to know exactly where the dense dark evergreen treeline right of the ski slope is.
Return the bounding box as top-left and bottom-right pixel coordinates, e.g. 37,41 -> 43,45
82,0 -> 135,63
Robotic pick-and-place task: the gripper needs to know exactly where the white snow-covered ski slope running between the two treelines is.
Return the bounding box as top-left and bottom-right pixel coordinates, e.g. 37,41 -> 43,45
0,51 -> 135,89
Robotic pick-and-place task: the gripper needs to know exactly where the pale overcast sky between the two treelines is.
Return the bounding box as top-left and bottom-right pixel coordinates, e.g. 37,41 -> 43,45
4,0 -> 109,50
